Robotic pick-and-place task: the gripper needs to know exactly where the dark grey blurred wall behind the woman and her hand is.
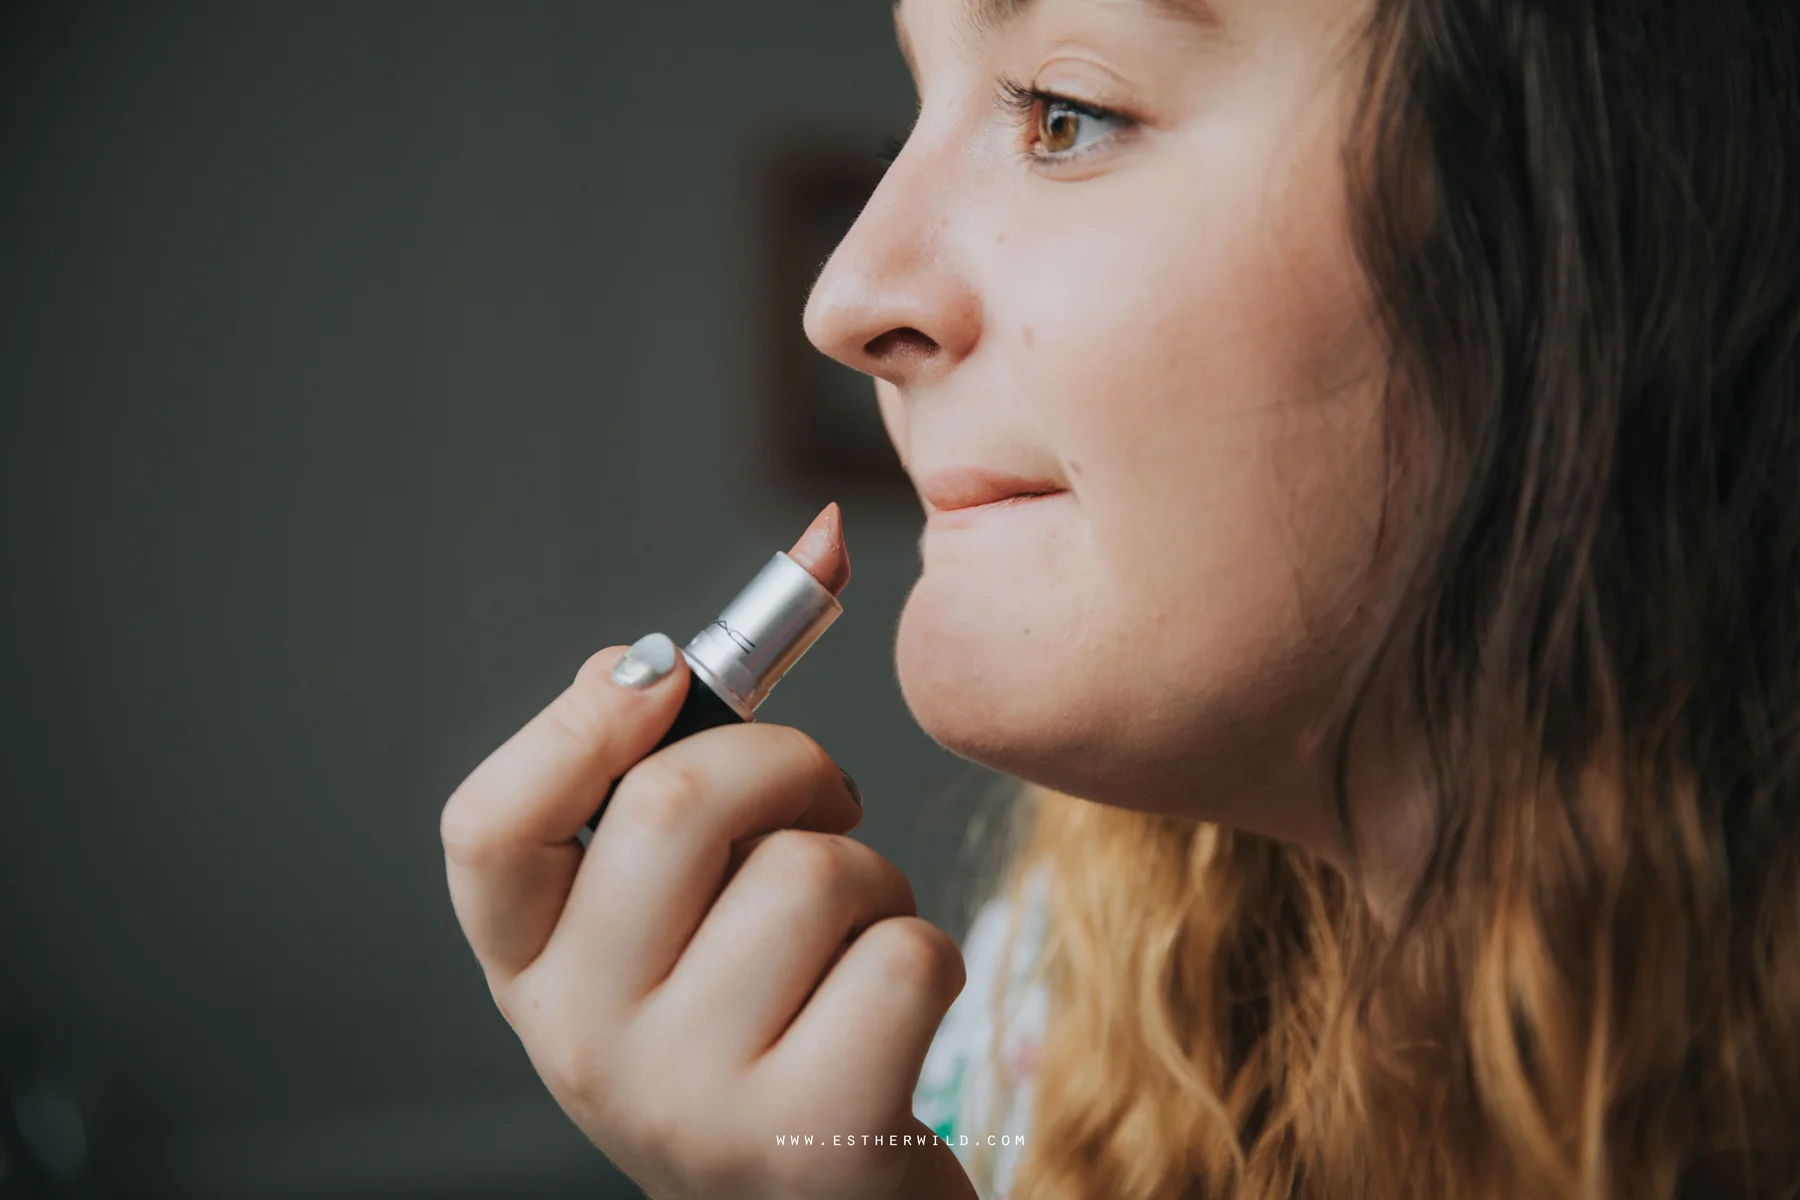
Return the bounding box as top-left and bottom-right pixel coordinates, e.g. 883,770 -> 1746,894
0,0 -> 1001,1200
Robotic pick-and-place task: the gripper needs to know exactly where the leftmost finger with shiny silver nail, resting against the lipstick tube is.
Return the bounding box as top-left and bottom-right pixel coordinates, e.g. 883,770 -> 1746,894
441,633 -> 689,988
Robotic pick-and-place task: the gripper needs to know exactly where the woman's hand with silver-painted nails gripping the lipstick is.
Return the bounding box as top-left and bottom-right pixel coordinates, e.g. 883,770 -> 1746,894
443,646 -> 976,1200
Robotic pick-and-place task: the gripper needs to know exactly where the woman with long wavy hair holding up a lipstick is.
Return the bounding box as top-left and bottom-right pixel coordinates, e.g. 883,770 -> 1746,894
445,0 -> 1800,1200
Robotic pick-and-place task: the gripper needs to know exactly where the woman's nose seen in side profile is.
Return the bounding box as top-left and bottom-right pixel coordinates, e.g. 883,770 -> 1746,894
805,140 -> 981,387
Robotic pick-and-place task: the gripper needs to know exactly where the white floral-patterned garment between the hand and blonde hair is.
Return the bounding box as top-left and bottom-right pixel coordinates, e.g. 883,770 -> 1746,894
913,869 -> 1048,1200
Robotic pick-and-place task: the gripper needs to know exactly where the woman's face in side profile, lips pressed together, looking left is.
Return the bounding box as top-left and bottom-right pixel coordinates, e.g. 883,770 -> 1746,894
805,0 -> 1386,852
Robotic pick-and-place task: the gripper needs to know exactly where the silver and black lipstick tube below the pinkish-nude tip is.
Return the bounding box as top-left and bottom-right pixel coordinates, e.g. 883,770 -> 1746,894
587,551 -> 844,829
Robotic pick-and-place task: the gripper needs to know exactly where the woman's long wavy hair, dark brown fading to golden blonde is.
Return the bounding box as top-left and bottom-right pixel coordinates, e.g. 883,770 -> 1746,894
964,0 -> 1800,1200
